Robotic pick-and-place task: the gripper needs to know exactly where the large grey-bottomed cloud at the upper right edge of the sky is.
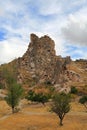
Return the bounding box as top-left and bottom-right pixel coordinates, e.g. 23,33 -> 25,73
62,9 -> 87,46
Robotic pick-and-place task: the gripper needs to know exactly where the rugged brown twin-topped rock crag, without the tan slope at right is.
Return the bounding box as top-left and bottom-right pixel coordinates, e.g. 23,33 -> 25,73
18,34 -> 80,88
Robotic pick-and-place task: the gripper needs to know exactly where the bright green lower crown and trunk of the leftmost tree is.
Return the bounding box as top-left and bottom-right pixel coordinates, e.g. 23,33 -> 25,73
5,82 -> 23,113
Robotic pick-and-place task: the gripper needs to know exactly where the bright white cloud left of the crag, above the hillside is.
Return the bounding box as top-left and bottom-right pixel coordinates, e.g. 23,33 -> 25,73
0,38 -> 27,64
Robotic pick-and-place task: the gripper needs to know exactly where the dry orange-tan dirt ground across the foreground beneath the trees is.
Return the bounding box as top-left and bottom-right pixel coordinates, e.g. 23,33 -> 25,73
0,101 -> 87,130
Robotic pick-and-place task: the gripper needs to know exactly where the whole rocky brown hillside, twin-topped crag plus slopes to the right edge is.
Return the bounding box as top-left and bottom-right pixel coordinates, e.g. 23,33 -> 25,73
0,34 -> 87,91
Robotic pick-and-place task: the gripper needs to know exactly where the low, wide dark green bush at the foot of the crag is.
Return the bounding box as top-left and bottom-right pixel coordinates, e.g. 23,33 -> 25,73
26,90 -> 50,104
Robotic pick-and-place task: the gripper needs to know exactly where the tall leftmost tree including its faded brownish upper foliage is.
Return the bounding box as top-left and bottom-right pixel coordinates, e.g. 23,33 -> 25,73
3,66 -> 23,113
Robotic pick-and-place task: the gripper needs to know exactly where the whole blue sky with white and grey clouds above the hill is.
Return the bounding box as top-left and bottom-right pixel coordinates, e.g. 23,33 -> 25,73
0,0 -> 87,64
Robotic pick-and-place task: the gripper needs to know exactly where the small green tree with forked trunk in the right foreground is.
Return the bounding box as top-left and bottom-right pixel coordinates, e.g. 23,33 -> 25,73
51,93 -> 70,126
